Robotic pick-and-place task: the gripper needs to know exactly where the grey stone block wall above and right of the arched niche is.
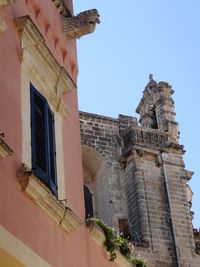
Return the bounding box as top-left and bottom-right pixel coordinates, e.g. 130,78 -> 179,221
79,112 -> 136,230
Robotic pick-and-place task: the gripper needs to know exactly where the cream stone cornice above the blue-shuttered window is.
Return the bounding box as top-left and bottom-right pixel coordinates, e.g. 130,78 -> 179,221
15,16 -> 76,116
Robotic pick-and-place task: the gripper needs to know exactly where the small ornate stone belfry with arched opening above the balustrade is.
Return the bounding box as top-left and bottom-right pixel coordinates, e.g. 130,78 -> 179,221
136,74 -> 179,144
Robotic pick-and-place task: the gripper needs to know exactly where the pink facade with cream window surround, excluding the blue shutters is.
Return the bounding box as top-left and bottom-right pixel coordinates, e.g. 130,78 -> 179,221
0,0 -> 123,267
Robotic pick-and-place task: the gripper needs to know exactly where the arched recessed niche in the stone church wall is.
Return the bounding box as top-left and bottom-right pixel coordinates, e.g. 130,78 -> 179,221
82,146 -> 112,225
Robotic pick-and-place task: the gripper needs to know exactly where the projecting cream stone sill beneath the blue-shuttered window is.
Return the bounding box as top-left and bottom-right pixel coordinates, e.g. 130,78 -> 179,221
17,164 -> 82,233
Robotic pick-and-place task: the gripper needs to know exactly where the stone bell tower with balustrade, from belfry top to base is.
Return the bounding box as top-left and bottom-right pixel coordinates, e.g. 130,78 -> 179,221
121,75 -> 200,267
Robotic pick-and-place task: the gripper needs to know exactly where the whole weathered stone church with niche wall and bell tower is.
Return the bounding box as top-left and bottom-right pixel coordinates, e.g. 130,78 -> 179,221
80,75 -> 200,267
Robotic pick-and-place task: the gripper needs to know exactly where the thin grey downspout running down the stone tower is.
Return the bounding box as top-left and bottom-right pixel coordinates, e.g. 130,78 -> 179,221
161,153 -> 181,267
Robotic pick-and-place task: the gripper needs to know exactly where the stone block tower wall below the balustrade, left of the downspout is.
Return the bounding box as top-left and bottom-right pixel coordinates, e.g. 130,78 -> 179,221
125,151 -> 175,267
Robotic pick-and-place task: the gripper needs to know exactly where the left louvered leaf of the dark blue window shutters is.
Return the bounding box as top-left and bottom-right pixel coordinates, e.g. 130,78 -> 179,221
31,85 -> 49,185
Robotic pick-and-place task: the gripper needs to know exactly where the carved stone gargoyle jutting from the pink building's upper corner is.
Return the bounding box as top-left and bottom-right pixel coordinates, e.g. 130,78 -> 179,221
62,9 -> 100,40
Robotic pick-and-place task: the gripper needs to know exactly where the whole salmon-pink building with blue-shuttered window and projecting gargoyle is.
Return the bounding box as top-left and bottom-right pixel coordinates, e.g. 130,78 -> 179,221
0,0 -> 129,267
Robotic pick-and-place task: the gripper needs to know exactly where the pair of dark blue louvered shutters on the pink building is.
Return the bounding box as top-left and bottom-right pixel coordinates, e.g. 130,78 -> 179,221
31,84 -> 57,198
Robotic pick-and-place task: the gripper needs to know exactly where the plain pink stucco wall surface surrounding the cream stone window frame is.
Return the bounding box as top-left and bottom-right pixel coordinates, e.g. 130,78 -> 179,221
0,0 -> 119,267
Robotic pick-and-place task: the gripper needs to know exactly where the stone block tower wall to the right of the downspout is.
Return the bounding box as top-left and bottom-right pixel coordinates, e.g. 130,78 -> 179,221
163,153 -> 200,266
